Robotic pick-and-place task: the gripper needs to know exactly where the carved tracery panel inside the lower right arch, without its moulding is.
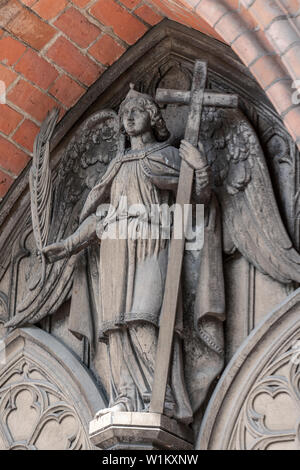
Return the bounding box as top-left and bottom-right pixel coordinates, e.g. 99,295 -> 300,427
229,336 -> 300,450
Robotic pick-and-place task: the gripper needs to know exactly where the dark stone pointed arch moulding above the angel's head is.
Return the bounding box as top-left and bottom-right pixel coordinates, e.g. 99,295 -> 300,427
0,19 -> 296,279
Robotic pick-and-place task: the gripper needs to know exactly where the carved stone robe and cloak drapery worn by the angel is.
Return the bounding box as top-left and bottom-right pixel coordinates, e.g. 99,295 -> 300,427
69,144 -> 225,423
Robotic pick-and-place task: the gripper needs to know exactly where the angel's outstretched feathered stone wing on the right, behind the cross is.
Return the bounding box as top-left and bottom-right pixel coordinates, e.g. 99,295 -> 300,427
201,109 -> 300,283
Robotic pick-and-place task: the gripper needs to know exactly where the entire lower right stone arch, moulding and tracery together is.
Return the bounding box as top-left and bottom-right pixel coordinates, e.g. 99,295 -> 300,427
196,289 -> 300,450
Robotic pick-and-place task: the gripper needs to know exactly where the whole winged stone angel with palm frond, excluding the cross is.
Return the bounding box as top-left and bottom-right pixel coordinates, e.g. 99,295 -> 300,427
6,74 -> 300,430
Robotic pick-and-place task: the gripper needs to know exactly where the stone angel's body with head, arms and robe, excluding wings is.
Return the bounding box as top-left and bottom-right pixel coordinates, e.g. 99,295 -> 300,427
43,83 -> 216,424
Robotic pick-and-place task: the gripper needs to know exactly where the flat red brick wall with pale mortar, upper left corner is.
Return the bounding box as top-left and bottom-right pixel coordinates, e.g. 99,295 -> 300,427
0,0 -> 163,198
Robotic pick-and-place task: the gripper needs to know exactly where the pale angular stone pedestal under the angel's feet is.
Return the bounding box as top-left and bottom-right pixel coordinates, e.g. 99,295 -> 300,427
90,412 -> 194,450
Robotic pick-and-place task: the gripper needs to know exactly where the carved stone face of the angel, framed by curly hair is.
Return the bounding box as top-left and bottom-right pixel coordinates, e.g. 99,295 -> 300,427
122,100 -> 152,137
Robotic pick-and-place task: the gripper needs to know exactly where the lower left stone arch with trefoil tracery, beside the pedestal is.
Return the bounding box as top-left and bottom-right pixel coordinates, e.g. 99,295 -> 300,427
0,327 -> 104,450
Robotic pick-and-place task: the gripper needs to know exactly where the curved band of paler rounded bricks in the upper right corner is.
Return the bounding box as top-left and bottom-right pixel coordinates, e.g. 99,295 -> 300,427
152,0 -> 300,148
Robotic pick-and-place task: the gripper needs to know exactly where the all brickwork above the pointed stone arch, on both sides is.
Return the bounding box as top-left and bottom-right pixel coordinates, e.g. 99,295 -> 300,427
0,0 -> 300,199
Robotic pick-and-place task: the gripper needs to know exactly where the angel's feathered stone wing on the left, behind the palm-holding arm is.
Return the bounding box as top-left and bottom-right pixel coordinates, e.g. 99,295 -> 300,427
5,110 -> 124,328
